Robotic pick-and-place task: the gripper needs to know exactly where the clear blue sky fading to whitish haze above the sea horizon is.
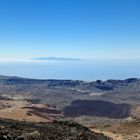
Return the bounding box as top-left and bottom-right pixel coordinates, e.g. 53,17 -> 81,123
0,0 -> 140,60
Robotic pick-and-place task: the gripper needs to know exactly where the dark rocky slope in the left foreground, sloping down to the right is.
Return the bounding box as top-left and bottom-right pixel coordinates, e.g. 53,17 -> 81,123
0,120 -> 110,140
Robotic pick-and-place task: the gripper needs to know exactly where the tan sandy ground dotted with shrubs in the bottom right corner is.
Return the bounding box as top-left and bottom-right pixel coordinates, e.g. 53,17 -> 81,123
91,120 -> 140,140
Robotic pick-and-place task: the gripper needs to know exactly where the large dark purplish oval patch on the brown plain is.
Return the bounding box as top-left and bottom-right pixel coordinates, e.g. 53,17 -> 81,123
64,100 -> 131,119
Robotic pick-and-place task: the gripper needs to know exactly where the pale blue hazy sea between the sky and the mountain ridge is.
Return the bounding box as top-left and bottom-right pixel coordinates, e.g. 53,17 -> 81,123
0,60 -> 140,81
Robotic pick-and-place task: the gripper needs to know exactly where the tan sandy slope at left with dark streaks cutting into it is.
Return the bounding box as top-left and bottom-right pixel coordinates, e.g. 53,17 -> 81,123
0,97 -> 49,122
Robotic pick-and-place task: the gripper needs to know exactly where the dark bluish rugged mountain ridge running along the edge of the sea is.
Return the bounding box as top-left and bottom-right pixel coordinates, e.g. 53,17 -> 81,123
0,76 -> 140,92
